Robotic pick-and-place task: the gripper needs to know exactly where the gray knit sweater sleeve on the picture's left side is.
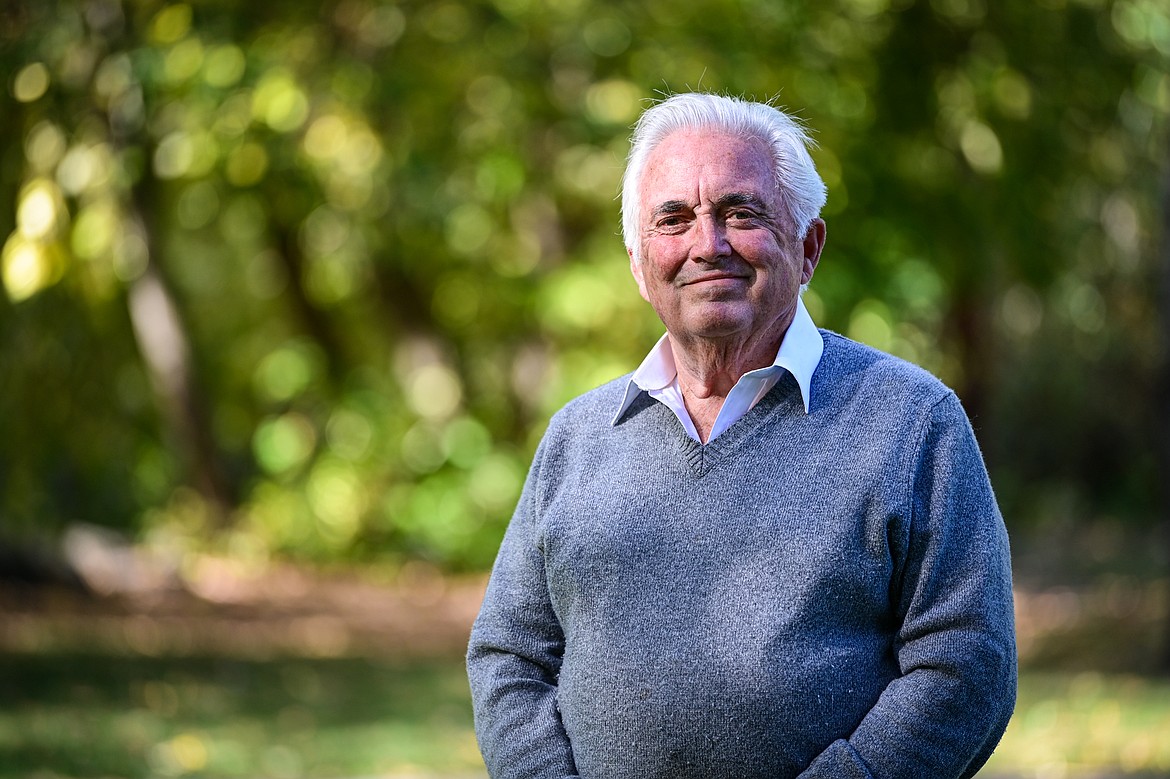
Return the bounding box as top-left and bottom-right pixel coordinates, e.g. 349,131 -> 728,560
467,432 -> 577,779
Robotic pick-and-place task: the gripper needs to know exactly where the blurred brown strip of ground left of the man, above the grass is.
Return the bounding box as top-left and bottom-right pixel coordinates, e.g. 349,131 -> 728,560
0,549 -> 486,661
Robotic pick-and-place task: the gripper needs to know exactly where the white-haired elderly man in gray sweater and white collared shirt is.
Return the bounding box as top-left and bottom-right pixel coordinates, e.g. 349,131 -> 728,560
468,94 -> 1016,779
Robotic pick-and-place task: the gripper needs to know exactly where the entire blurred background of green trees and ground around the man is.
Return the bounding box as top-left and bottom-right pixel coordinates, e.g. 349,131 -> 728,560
0,0 -> 1170,779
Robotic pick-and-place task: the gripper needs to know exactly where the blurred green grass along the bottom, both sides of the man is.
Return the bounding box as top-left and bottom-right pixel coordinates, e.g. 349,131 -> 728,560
0,653 -> 1170,779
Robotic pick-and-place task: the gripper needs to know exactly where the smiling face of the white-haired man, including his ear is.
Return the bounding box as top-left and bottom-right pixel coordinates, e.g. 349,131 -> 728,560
631,130 -> 825,343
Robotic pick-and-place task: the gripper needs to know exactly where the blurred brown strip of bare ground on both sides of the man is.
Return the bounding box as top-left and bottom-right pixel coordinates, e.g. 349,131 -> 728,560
0,558 -> 1170,673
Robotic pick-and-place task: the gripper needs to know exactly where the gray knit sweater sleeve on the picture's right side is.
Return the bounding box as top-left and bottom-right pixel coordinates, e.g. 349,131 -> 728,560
799,393 -> 1017,779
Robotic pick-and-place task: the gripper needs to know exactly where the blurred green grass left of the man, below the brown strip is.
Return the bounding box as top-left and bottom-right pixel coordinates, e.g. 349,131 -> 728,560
0,653 -> 482,779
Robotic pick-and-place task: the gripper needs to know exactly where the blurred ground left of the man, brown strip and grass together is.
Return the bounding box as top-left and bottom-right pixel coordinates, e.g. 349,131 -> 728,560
0,560 -> 483,779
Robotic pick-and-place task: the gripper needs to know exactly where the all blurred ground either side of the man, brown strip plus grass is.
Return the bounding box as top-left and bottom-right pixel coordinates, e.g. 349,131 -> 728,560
0,521 -> 1170,779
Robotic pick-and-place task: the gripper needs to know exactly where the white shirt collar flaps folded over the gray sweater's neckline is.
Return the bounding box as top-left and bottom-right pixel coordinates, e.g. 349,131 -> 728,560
613,298 -> 825,425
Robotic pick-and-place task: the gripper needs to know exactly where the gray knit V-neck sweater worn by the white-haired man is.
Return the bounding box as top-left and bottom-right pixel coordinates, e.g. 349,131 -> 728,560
467,331 -> 1016,779
